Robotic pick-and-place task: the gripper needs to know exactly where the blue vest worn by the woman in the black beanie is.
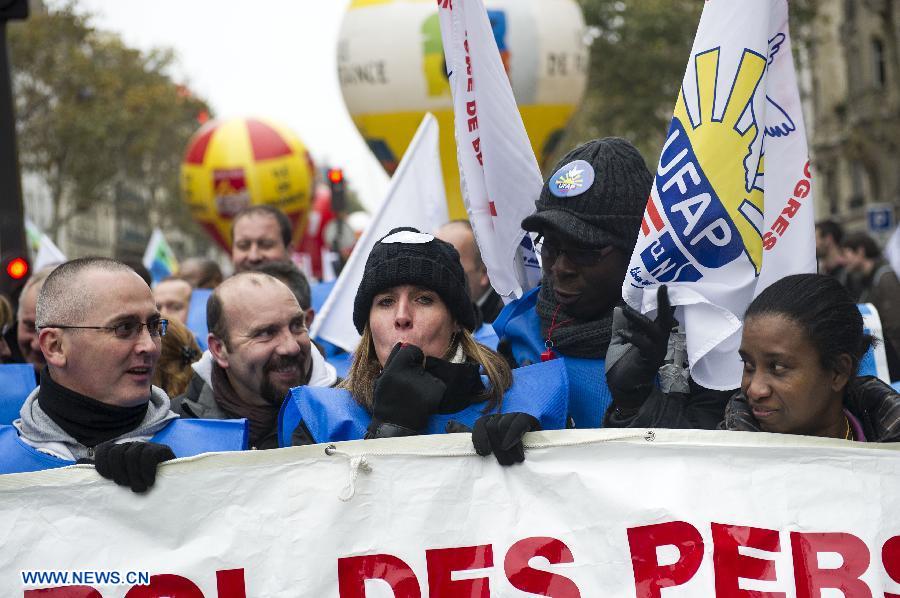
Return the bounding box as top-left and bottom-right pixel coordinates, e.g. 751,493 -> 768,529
278,361 -> 569,447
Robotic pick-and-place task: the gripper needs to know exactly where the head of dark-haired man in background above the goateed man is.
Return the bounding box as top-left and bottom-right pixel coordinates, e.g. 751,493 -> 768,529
231,205 -> 292,272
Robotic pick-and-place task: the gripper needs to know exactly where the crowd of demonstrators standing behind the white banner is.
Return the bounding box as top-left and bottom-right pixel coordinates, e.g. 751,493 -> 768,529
0,138 -> 900,492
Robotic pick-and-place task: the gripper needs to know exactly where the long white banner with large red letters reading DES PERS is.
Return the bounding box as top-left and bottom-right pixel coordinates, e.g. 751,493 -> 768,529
0,430 -> 900,598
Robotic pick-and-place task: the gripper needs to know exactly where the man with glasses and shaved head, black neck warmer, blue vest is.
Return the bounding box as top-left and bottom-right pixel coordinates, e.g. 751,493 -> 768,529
0,258 -> 245,492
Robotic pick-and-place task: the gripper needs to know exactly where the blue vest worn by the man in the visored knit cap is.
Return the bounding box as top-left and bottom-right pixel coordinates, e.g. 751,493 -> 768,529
494,287 -> 612,428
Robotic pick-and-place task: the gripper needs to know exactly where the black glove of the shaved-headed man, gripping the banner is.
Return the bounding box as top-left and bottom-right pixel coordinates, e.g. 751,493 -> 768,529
94,441 -> 175,492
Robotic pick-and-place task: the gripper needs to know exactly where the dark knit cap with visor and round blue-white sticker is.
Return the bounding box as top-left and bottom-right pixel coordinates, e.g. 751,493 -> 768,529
522,137 -> 653,255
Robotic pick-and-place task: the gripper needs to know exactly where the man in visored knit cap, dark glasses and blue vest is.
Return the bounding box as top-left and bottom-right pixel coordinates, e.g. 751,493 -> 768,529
494,138 -> 653,428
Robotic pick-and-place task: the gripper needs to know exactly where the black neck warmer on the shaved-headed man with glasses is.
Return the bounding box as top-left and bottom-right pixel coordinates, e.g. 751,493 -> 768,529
37,367 -> 148,448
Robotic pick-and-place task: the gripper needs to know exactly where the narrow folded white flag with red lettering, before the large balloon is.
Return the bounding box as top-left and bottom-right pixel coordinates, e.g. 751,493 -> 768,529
438,0 -> 543,301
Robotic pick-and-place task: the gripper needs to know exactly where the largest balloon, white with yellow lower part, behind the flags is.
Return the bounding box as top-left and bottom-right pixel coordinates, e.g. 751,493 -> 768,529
338,0 -> 588,218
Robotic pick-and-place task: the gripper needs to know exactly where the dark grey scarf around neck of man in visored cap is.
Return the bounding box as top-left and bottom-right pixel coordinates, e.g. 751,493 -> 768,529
537,276 -> 613,359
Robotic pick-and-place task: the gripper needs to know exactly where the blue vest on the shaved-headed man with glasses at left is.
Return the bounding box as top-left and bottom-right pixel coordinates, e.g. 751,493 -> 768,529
0,419 -> 250,474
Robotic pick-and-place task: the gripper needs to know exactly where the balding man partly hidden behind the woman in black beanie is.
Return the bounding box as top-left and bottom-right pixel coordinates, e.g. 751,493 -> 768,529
434,220 -> 503,330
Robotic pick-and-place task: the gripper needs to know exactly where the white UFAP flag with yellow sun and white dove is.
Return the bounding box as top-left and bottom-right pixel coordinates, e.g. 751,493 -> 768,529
622,0 -> 816,390
